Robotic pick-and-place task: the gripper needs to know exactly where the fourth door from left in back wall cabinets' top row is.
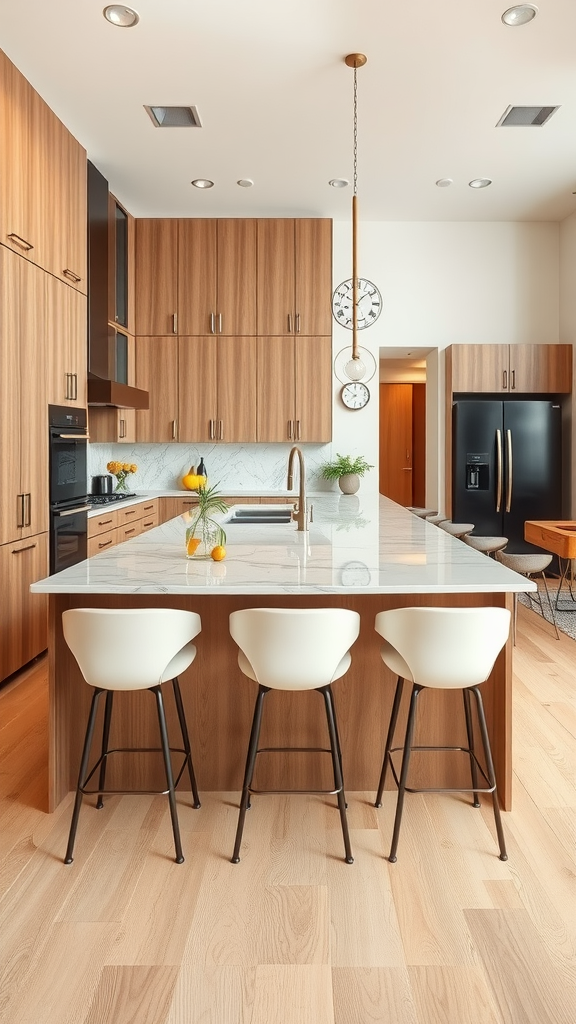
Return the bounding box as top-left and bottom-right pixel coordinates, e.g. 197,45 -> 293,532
257,218 -> 296,337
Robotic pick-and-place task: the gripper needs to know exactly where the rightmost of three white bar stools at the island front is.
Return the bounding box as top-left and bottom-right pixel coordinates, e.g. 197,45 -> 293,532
375,608 -> 510,863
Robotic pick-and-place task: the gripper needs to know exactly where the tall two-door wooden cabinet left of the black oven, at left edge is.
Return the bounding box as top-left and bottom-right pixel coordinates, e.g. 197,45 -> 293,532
0,246 -> 49,544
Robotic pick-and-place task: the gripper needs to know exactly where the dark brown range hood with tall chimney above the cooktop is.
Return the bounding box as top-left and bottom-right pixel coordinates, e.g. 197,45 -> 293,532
88,161 -> 150,409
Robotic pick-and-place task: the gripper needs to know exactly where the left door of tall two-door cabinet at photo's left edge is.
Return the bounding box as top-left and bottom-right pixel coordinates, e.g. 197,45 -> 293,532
0,246 -> 22,544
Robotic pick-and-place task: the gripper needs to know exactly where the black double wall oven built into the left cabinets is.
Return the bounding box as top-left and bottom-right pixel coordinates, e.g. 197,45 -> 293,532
48,406 -> 90,573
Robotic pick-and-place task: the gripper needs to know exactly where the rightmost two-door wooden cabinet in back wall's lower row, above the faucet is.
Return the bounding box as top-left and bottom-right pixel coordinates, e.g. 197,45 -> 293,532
257,337 -> 332,441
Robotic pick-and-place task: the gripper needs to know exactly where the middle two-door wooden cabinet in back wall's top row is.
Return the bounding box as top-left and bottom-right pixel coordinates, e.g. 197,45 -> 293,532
178,219 -> 256,338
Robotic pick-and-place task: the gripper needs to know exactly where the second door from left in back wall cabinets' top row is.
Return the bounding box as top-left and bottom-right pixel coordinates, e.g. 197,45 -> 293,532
177,218 -> 217,336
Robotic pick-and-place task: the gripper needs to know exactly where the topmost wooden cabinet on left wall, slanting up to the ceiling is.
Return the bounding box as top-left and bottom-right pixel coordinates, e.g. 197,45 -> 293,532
0,51 -> 87,293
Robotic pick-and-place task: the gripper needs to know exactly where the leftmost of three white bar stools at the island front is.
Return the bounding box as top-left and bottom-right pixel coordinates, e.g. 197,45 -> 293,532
63,608 -> 202,864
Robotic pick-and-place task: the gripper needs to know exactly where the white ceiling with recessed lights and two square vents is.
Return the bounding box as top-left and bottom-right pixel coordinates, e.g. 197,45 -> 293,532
0,0 -> 576,220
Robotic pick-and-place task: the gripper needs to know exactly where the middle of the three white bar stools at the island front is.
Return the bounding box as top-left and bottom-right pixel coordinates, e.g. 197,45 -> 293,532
230,608 -> 360,864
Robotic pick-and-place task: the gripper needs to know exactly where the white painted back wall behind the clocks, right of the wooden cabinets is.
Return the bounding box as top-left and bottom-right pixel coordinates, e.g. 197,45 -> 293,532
334,221 -> 560,505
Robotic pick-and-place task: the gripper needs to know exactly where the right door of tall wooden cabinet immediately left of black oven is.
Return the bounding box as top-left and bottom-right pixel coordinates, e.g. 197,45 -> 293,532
19,260 -> 48,538
